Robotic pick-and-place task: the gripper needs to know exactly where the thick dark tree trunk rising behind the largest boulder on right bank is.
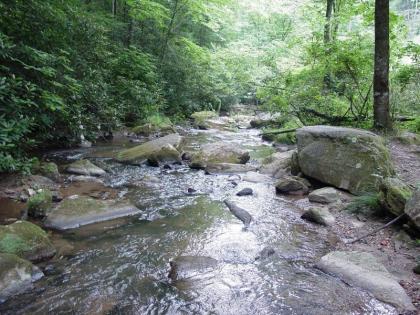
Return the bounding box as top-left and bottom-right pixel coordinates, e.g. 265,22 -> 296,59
373,0 -> 392,130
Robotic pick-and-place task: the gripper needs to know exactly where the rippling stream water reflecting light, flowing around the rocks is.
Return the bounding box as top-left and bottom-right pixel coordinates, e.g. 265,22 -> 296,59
0,125 -> 395,315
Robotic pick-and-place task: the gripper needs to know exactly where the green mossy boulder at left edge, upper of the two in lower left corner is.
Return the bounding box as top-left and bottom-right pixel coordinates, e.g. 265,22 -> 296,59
0,221 -> 55,261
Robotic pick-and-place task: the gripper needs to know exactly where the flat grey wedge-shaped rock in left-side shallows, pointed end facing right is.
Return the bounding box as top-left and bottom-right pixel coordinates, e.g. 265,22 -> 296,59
45,196 -> 140,230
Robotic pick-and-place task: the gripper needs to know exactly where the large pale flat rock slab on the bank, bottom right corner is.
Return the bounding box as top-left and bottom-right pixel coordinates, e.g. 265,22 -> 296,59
317,251 -> 415,310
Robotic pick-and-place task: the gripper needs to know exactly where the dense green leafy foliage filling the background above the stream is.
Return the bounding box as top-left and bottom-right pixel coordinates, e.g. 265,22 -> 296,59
0,0 -> 420,172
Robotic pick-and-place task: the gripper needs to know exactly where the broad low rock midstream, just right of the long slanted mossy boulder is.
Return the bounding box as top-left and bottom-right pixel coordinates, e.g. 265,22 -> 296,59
190,142 -> 250,169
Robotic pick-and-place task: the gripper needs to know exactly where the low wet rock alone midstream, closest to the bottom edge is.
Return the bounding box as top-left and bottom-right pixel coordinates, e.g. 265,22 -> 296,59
168,256 -> 218,281
